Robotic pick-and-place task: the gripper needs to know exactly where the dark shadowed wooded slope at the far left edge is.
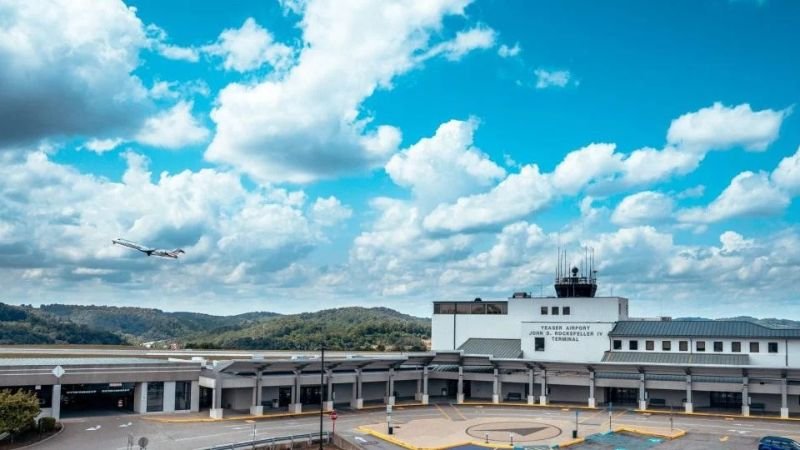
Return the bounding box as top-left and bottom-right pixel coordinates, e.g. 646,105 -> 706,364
0,303 -> 127,345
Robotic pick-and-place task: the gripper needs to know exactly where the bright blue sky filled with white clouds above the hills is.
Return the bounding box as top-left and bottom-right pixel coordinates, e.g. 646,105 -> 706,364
0,0 -> 800,319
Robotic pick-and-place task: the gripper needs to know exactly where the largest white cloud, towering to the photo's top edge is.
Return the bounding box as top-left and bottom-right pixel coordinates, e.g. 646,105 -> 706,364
206,0 -> 490,183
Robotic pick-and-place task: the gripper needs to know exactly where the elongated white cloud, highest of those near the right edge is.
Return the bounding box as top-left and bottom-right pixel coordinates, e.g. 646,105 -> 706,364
667,102 -> 790,152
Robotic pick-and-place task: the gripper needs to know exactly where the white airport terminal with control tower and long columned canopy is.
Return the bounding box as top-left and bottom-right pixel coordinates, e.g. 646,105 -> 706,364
0,268 -> 800,418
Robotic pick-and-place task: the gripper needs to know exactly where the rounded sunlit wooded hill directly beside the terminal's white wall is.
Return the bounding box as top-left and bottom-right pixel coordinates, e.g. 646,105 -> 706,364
186,307 -> 431,351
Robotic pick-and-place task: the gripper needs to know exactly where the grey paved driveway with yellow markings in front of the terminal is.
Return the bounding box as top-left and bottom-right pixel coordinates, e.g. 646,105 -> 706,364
35,405 -> 800,450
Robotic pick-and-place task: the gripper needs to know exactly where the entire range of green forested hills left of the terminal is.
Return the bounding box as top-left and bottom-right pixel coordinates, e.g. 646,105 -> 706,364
0,303 -> 431,351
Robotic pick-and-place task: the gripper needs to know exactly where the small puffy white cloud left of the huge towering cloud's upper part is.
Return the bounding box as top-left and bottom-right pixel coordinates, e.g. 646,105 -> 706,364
203,17 -> 293,72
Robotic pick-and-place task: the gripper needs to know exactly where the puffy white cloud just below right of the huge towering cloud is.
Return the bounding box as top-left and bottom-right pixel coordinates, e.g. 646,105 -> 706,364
386,119 -> 505,206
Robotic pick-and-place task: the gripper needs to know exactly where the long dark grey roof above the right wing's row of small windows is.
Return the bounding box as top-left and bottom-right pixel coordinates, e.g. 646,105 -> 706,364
608,320 -> 800,339
